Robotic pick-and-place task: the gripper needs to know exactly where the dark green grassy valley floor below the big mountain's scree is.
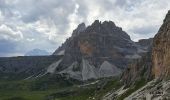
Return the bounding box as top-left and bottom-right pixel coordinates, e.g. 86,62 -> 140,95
0,77 -> 120,100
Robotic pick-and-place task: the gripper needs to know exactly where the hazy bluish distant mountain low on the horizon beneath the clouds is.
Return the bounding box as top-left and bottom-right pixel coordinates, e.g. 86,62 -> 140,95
25,49 -> 50,56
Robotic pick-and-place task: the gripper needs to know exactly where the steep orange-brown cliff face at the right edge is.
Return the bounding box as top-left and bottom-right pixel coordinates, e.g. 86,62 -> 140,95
152,11 -> 170,79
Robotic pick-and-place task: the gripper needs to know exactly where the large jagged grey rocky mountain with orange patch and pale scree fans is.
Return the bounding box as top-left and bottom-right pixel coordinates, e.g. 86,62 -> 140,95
50,20 -> 146,80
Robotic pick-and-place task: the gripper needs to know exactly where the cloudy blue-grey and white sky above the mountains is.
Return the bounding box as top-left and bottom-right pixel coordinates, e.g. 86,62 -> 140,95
0,0 -> 170,57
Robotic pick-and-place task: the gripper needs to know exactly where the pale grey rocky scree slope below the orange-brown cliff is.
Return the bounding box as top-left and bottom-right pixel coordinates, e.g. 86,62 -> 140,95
125,80 -> 170,100
